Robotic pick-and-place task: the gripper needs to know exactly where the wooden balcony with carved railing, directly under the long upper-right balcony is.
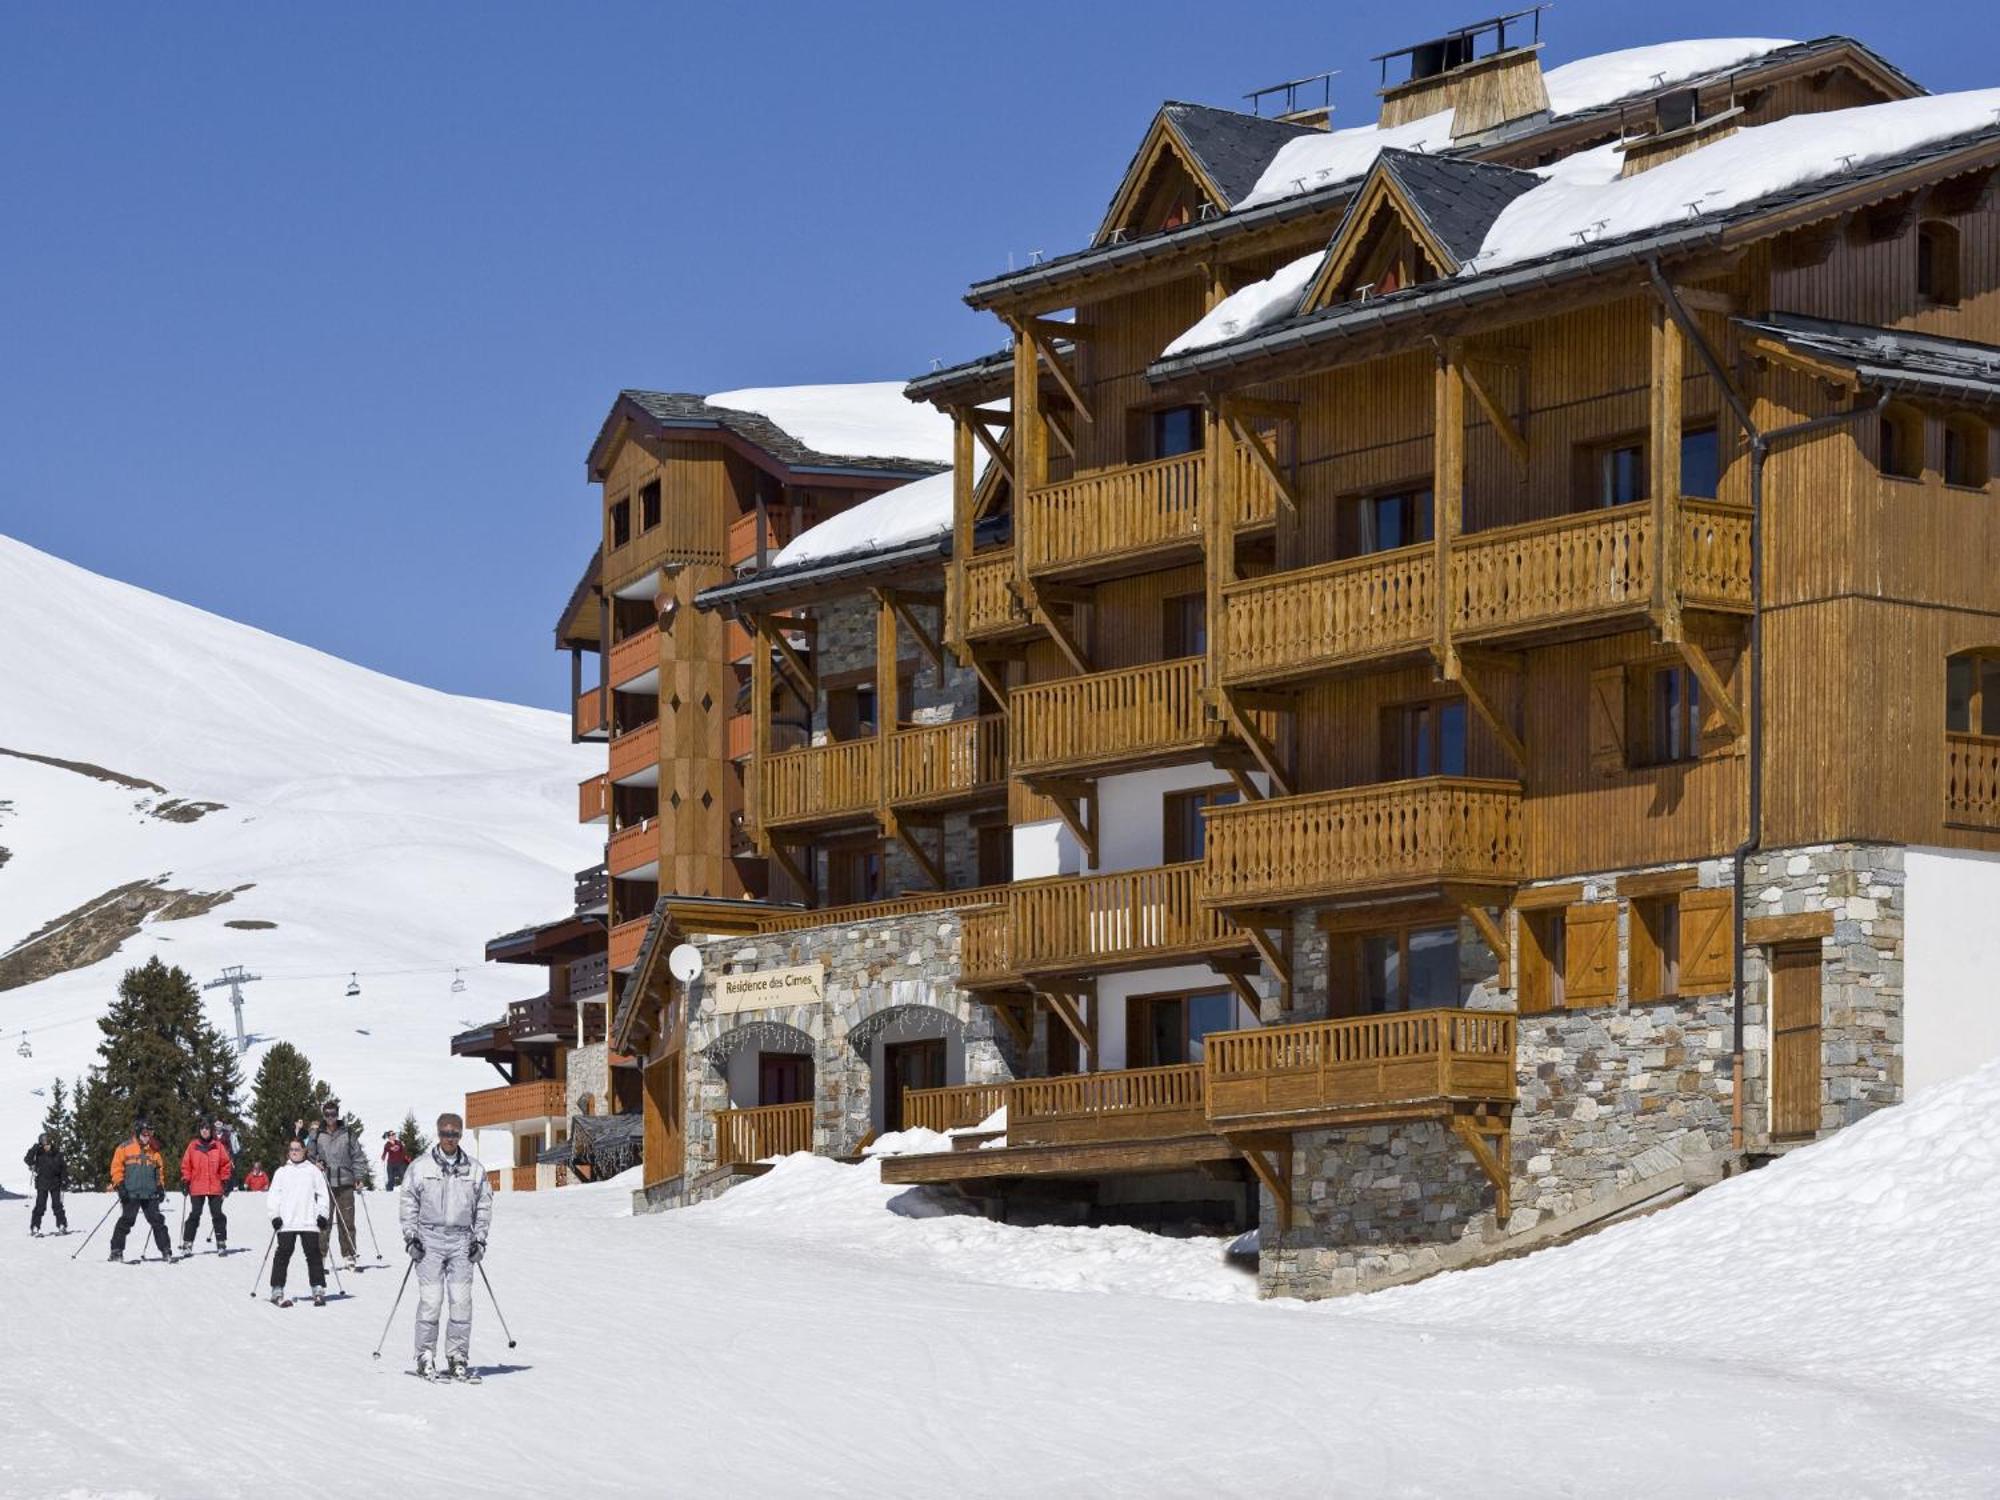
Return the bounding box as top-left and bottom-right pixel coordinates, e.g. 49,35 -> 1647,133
1204,776 -> 1522,906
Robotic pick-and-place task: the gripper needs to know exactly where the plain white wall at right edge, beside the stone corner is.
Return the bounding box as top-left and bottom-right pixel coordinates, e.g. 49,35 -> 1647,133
1902,848 -> 2000,1096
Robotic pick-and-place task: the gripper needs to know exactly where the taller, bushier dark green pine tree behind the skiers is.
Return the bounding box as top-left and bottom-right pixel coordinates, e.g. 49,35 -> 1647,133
76,958 -> 242,1186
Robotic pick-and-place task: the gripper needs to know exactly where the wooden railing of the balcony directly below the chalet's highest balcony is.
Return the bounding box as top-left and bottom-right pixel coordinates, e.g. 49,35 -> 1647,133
1008,656 -> 1218,774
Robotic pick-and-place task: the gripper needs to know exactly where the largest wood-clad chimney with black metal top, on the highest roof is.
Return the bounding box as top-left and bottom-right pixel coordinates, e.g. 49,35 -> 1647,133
1370,6 -> 1548,140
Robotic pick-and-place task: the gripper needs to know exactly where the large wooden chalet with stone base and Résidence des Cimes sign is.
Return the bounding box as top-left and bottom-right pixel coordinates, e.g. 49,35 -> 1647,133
504,12 -> 2000,1296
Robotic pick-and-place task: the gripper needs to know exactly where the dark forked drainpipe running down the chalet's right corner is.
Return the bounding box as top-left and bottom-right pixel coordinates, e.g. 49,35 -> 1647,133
1646,258 -> 1888,1152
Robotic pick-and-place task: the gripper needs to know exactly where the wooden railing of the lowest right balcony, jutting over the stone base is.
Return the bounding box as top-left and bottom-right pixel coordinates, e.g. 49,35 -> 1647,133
1202,1010 -> 1516,1126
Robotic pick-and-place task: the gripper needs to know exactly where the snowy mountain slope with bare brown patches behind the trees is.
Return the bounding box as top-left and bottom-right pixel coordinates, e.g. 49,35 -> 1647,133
0,538 -> 602,1182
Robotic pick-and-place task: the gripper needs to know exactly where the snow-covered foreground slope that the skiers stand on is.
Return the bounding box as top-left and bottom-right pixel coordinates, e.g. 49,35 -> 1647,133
0,1066 -> 2000,1500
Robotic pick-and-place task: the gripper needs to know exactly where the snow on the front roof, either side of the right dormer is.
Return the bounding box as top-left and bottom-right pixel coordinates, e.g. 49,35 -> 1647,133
1162,88 -> 2000,358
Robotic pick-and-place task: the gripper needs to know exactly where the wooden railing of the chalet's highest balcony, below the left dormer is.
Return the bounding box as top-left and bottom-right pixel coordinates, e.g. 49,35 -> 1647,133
1016,452 -> 1206,574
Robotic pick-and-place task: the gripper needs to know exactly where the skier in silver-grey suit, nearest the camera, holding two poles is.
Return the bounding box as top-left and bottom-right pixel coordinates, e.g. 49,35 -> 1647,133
398,1114 -> 494,1380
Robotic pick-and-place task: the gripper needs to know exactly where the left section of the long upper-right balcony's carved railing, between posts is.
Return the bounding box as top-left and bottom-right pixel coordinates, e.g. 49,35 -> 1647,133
1222,546 -> 1438,682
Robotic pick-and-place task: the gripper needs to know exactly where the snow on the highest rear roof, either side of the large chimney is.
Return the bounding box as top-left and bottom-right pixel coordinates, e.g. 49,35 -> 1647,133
1236,36 -> 1796,210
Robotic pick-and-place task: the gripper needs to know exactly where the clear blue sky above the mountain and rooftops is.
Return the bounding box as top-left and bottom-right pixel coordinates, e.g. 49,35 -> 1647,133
0,0 -> 2000,706
